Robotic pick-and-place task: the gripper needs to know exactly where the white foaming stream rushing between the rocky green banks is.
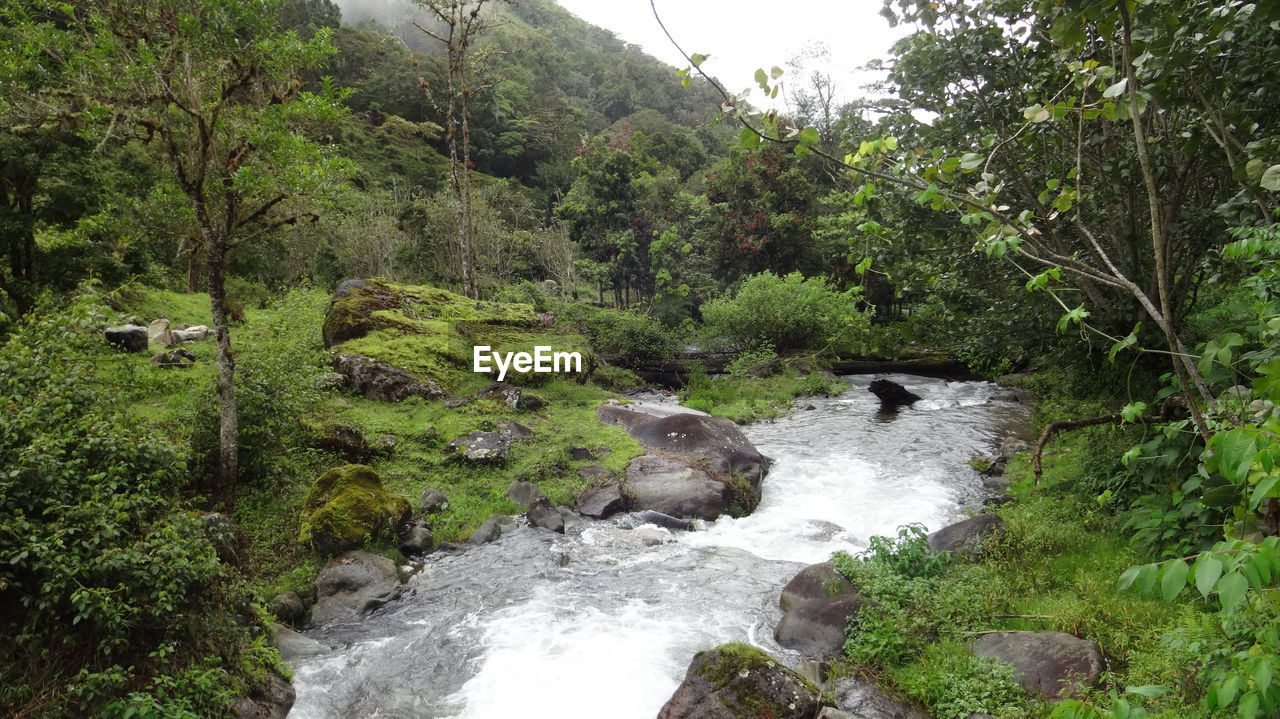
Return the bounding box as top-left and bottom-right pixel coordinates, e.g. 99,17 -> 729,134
289,375 -> 1025,719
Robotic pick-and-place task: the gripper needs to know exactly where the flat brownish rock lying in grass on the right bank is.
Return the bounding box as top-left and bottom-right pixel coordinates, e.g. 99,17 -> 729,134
969,632 -> 1106,701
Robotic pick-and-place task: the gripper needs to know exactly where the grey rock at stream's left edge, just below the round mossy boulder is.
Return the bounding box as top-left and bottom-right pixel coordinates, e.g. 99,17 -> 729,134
311,550 -> 401,626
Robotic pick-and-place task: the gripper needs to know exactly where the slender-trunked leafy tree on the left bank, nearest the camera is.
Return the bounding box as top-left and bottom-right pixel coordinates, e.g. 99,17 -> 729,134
5,0 -> 351,487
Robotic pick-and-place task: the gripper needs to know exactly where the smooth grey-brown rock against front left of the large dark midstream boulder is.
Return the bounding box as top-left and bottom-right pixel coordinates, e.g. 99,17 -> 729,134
623,454 -> 733,519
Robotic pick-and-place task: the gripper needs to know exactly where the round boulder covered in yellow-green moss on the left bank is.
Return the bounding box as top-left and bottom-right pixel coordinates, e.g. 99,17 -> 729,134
300,464 -> 410,554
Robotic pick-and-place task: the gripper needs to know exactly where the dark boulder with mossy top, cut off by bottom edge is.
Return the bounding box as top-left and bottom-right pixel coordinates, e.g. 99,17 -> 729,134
658,644 -> 823,719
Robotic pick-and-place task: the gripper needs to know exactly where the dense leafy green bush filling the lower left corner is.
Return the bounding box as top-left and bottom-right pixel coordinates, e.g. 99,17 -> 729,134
0,298 -> 274,716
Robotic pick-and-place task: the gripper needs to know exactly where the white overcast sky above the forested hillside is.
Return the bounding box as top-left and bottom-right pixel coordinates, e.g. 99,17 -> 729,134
557,0 -> 908,104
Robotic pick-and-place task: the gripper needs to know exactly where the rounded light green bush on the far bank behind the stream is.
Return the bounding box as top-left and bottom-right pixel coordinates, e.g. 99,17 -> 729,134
701,271 -> 870,352
